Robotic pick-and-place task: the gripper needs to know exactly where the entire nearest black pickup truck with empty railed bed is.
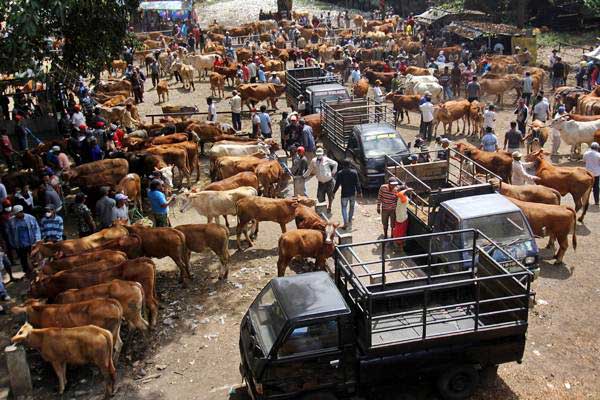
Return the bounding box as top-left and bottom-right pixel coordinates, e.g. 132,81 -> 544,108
239,230 -> 532,400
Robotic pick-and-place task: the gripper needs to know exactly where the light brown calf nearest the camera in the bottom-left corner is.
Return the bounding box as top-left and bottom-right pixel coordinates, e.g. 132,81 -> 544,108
11,323 -> 117,396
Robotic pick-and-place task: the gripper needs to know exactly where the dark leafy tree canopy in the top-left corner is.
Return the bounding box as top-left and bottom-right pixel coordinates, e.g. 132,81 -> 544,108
0,0 -> 138,76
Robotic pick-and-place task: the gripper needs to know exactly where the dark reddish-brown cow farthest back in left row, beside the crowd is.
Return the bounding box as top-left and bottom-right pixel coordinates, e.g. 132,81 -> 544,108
62,158 -> 129,187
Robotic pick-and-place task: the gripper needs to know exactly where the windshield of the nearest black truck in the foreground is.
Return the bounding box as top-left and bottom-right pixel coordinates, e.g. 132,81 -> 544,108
250,287 -> 286,357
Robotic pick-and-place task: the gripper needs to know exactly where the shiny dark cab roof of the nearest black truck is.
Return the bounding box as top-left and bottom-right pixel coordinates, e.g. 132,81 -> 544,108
271,271 -> 350,320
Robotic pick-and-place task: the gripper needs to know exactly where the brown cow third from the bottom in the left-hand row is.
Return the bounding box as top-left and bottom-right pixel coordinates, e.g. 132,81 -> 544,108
54,279 -> 149,331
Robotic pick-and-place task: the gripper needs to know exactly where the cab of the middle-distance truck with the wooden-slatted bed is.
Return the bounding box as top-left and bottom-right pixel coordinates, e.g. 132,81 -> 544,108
346,122 -> 410,188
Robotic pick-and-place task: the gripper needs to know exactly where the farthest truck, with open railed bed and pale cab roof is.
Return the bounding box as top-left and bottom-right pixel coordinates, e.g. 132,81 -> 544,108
285,67 -> 350,114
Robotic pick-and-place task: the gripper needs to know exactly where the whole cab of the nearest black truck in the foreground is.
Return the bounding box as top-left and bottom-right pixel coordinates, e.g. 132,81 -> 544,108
240,272 -> 353,398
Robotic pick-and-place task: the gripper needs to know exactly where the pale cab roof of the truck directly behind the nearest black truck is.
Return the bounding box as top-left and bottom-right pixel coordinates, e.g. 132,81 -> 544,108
442,193 -> 519,220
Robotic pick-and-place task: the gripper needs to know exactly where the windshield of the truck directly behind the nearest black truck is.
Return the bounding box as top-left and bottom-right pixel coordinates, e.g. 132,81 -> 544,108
465,212 -> 531,245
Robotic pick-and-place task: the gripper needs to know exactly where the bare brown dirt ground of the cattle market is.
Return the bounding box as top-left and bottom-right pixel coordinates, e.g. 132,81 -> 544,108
0,2 -> 600,400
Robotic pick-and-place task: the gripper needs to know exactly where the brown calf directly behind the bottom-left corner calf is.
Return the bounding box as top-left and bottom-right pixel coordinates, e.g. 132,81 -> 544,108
11,299 -> 123,362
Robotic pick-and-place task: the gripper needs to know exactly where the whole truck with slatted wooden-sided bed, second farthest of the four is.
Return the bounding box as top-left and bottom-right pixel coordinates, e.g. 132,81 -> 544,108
321,99 -> 410,189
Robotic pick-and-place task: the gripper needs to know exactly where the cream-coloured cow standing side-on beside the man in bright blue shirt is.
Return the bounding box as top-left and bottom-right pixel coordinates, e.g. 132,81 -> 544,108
178,186 -> 258,226
